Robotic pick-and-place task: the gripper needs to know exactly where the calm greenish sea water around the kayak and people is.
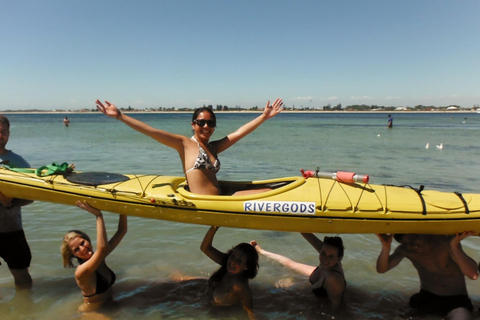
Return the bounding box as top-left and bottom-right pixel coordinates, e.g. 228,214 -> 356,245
0,112 -> 480,320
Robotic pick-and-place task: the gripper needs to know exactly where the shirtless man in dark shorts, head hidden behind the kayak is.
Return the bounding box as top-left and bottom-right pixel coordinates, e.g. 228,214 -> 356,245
377,231 -> 478,319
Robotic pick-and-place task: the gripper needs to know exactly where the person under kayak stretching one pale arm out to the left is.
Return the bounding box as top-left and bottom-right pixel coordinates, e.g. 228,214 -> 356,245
251,233 -> 347,310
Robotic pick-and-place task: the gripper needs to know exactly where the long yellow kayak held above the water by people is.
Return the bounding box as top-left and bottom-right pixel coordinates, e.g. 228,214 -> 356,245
0,168 -> 480,234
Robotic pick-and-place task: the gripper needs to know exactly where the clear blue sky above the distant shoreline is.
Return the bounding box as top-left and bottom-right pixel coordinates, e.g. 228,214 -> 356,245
0,0 -> 480,110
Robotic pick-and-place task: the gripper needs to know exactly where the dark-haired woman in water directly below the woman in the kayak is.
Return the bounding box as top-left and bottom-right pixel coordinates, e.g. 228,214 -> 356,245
200,226 -> 258,319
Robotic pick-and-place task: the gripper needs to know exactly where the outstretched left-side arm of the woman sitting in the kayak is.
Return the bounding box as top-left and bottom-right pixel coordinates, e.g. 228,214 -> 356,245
95,100 -> 188,153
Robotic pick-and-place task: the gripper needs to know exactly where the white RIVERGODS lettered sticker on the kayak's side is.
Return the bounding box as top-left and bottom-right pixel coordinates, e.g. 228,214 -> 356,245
243,201 -> 315,214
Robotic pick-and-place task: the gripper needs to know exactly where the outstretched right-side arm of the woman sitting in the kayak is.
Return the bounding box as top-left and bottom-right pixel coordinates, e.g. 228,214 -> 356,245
212,98 -> 283,153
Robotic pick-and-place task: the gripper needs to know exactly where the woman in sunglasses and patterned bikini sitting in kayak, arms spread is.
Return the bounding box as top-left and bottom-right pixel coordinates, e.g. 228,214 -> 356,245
96,98 -> 283,195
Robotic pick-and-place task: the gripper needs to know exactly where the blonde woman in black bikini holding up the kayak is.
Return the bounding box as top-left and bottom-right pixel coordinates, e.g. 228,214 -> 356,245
61,201 -> 127,312
